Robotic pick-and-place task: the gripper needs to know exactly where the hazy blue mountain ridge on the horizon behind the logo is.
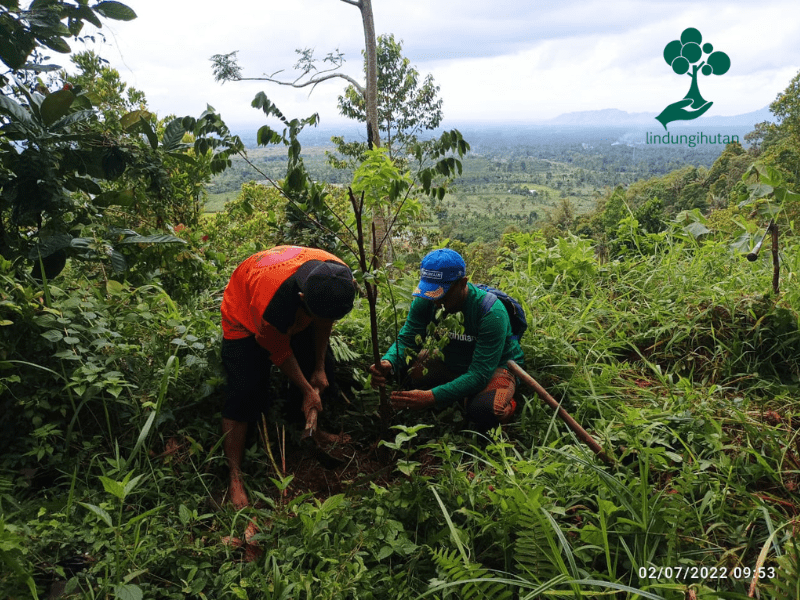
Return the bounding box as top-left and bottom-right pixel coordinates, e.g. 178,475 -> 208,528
542,106 -> 775,129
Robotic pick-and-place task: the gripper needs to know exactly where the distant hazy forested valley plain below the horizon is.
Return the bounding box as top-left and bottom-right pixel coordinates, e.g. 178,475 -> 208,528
206,123 -> 748,243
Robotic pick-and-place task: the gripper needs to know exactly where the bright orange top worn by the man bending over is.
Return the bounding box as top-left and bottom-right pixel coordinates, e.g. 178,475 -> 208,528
221,246 -> 345,366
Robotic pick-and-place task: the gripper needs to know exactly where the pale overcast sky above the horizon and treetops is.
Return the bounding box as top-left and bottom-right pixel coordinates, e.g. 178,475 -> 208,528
76,0 -> 800,131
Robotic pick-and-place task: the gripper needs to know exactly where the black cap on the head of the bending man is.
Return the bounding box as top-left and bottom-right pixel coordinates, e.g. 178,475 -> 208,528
300,262 -> 356,320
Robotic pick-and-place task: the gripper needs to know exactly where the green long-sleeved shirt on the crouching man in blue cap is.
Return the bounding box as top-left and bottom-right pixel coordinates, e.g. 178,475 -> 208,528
383,283 -> 523,408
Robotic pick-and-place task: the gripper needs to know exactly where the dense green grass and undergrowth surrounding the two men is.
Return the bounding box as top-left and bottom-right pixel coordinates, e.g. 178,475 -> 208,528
0,213 -> 800,599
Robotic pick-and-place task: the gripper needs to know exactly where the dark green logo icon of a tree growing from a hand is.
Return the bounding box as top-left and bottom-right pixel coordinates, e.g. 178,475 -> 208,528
656,27 -> 731,129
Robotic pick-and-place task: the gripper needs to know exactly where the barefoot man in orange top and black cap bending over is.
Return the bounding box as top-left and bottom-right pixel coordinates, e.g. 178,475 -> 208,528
221,246 -> 355,508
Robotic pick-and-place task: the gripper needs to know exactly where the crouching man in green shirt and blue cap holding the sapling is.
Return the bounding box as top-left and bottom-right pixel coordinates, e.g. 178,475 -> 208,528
369,248 -> 523,431
